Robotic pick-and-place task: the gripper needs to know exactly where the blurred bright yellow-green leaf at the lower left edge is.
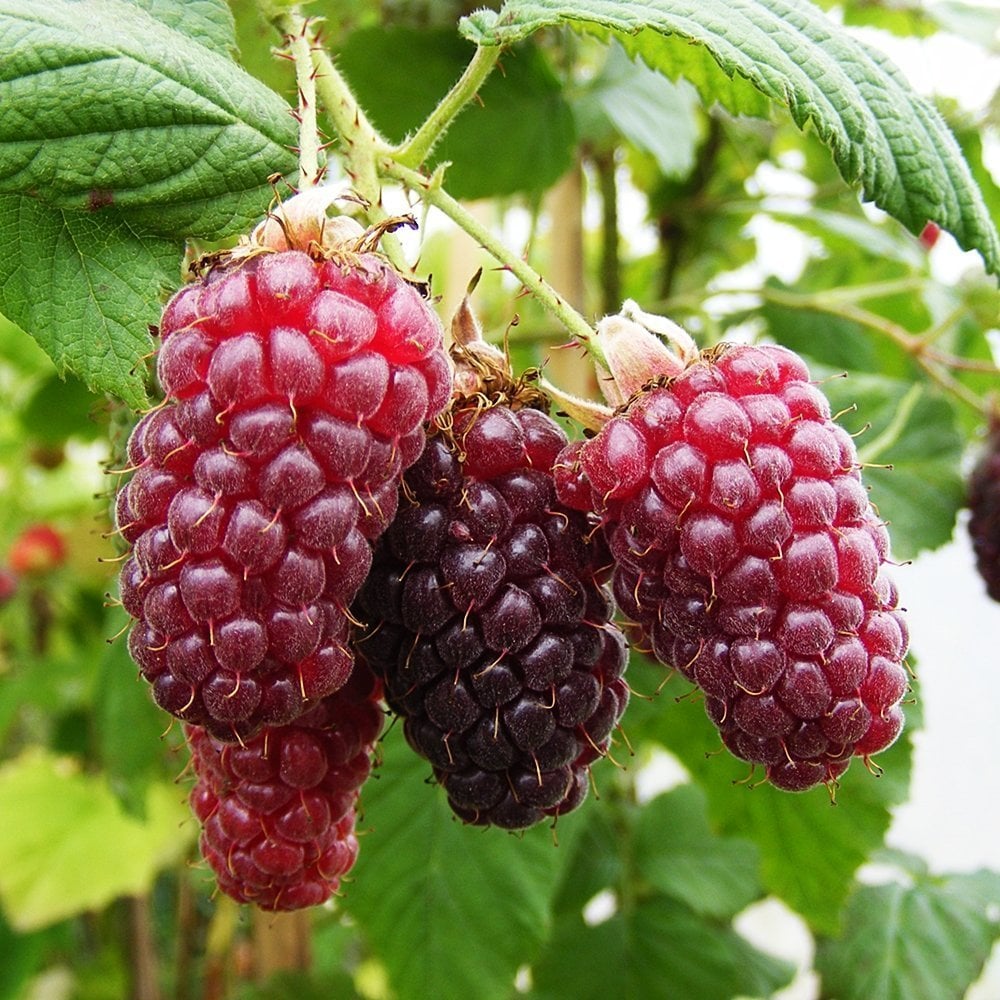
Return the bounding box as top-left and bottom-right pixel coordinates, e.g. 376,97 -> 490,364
0,751 -> 195,931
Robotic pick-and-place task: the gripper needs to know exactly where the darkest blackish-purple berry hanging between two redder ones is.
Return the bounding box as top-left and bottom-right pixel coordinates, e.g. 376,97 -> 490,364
355,334 -> 628,829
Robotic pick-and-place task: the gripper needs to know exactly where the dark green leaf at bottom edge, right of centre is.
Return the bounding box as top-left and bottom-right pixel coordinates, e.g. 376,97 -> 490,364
531,894 -> 794,1000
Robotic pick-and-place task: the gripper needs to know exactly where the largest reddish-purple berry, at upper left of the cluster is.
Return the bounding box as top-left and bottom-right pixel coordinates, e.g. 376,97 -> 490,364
116,201 -> 450,741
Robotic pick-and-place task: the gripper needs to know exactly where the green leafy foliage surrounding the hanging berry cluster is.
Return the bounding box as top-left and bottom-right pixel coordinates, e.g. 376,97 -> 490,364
0,0 -> 1000,1000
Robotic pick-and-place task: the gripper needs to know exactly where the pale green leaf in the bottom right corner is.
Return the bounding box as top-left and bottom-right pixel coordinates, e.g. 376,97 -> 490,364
816,871 -> 1000,1000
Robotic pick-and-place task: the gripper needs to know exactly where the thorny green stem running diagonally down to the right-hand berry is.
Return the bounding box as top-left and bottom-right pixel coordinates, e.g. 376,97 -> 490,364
379,157 -> 606,364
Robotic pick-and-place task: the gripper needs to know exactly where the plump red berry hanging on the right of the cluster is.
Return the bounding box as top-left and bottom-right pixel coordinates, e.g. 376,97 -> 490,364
560,308 -> 908,790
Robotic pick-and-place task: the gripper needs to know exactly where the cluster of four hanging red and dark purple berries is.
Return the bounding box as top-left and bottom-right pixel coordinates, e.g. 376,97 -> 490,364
116,211 -> 912,909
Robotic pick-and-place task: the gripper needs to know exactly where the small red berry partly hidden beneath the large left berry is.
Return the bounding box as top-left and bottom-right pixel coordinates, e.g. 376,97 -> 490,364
184,664 -> 383,910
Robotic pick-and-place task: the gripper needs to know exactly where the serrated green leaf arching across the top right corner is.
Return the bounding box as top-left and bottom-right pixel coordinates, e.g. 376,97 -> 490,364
461,0 -> 1000,274
